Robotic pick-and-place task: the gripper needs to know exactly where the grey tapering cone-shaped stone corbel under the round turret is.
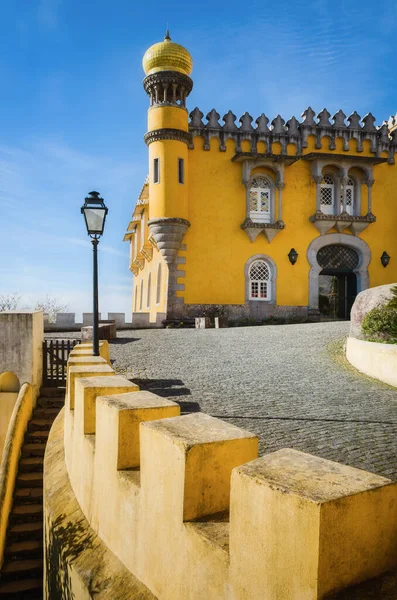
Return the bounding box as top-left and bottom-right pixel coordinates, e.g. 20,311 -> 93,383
148,218 -> 190,265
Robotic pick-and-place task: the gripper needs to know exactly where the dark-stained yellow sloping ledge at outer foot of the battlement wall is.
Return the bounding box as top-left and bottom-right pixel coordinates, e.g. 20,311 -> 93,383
44,410 -> 157,600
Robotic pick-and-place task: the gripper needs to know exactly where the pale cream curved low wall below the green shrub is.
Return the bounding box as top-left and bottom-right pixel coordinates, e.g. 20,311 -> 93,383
346,337 -> 397,387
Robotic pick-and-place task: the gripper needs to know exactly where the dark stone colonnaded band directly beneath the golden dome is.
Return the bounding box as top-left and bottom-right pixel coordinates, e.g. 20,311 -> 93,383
143,71 -> 193,109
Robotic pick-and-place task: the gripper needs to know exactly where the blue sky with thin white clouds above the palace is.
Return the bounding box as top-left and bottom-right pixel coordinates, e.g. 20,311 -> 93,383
0,0 -> 397,313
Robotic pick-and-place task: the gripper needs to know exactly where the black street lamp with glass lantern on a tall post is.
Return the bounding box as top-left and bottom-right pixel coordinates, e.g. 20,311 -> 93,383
81,192 -> 108,356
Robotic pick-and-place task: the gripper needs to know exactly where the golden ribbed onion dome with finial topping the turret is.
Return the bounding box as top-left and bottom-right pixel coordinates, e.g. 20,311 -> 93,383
142,31 -> 193,75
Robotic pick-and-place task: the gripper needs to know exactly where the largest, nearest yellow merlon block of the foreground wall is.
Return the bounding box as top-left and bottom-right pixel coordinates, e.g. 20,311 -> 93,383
230,449 -> 397,600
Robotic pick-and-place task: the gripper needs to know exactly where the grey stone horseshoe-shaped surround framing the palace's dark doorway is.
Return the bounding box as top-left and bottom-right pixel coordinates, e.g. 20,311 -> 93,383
307,233 -> 371,314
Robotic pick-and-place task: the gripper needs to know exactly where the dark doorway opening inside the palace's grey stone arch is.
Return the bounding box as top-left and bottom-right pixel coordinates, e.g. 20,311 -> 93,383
317,244 -> 359,320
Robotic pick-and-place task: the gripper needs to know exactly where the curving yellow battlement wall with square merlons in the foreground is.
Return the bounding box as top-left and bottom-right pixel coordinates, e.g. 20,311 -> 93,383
45,355 -> 397,600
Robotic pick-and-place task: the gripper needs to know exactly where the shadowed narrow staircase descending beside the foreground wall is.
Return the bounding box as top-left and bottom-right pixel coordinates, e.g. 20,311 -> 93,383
0,388 -> 65,600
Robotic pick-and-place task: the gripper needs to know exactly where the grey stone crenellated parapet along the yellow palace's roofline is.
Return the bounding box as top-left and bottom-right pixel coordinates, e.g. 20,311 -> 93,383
189,106 -> 397,164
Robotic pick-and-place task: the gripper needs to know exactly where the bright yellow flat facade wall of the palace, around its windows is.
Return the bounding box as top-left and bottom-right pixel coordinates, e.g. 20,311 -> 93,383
182,136 -> 397,305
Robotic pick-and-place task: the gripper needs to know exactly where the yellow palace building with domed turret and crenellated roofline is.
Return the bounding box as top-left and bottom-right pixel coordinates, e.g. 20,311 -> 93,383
124,32 -> 397,327
